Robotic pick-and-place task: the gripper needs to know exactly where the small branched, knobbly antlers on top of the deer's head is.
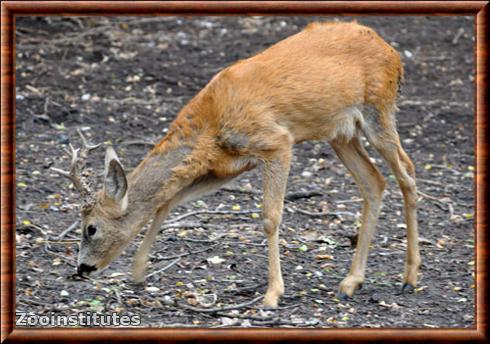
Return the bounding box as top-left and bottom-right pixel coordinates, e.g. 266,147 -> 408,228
51,129 -> 101,210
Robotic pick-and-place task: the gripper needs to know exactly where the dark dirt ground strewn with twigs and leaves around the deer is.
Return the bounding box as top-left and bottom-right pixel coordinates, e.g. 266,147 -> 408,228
16,16 -> 475,327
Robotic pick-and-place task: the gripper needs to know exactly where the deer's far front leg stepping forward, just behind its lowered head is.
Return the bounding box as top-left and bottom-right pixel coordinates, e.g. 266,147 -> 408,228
132,207 -> 168,283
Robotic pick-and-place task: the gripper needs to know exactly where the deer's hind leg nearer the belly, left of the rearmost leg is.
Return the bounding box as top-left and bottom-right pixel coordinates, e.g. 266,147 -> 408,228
330,137 -> 385,299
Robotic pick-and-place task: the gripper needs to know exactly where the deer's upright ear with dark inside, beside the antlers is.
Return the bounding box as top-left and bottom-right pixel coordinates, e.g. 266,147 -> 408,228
104,147 -> 128,211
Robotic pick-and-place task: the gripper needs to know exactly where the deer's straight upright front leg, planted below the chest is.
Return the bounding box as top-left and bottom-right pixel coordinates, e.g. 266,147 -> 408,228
263,149 -> 291,308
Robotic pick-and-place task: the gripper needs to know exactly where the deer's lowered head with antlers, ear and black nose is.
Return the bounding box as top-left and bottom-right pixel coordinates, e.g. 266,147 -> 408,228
52,130 -> 131,275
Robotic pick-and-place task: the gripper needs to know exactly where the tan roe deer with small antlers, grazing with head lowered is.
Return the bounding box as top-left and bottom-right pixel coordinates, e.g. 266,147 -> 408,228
52,22 -> 420,307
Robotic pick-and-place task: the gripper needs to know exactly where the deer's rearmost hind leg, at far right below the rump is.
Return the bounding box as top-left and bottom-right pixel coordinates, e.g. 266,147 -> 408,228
365,107 -> 421,292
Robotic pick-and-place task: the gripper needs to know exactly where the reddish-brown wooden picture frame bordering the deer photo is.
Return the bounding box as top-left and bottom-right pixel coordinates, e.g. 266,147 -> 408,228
1,1 -> 489,343
